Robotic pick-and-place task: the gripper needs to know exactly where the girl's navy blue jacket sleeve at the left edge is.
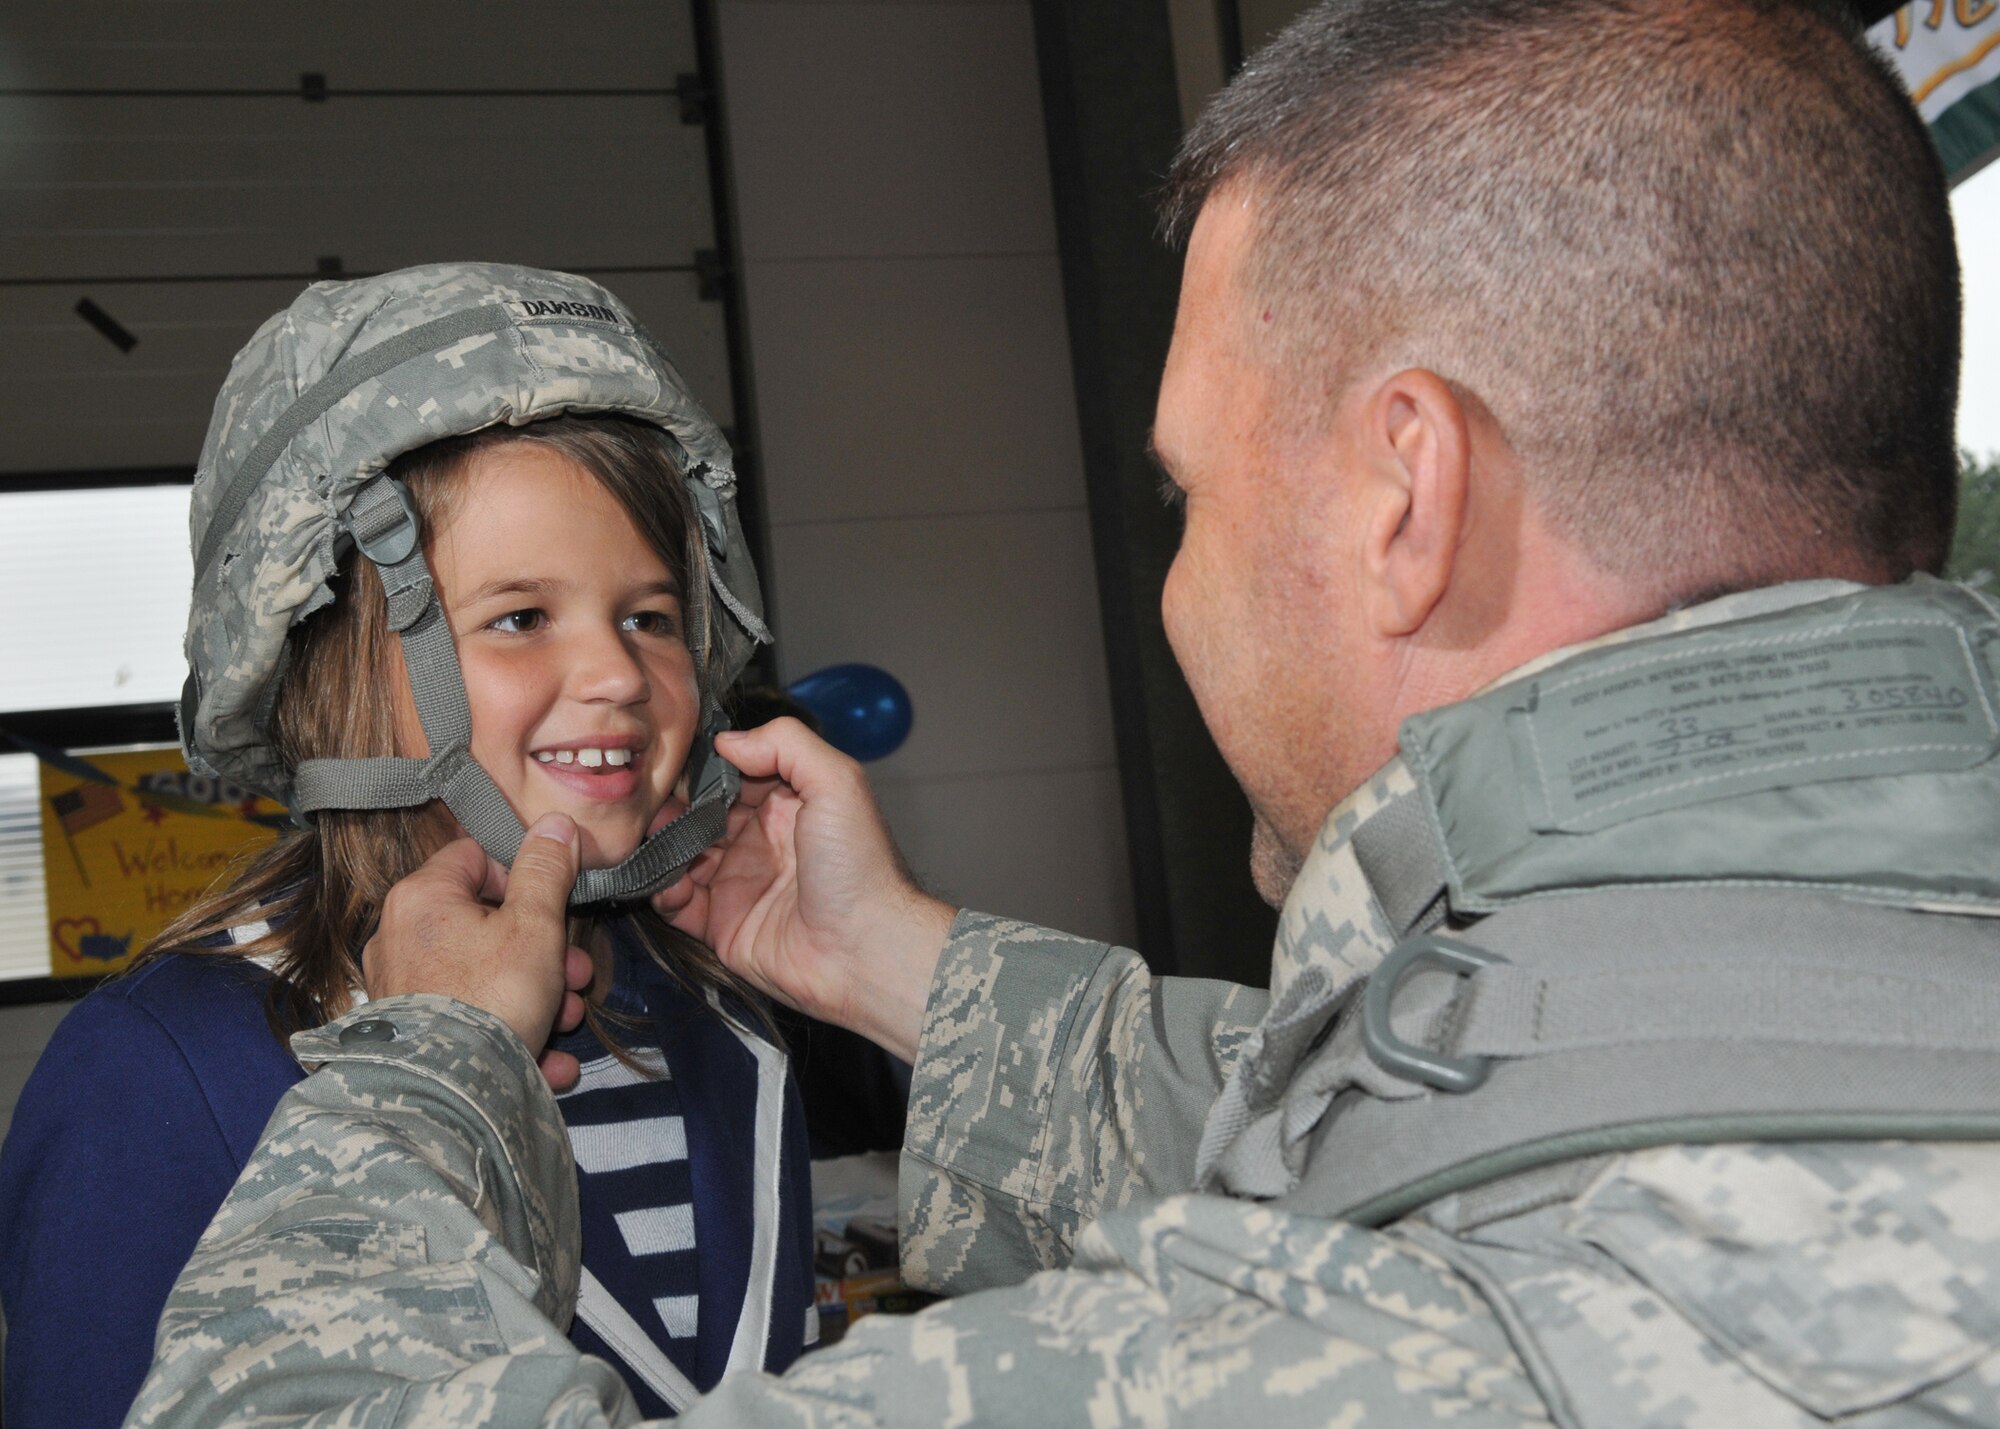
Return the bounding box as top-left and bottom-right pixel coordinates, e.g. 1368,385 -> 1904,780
0,993 -> 236,1429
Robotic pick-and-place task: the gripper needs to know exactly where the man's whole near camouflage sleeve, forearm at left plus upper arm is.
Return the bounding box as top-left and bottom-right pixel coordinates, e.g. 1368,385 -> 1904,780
132,997 -> 1546,1429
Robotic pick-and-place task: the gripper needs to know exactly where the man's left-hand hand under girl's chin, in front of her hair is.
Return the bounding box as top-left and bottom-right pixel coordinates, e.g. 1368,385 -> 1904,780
362,815 -> 592,1091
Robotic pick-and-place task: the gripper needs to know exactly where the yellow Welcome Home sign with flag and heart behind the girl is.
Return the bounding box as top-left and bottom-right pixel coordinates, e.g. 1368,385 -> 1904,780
40,749 -> 284,977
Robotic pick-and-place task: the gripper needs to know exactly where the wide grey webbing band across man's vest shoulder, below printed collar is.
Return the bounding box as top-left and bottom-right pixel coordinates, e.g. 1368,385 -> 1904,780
1284,887 -> 2000,1225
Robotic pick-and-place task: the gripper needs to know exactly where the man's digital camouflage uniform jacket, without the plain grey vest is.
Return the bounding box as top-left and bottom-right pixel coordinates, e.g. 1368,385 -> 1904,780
134,584 -> 2000,1429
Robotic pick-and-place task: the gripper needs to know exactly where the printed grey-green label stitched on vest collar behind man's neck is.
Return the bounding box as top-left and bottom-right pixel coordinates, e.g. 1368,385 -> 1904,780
1508,616 -> 2000,833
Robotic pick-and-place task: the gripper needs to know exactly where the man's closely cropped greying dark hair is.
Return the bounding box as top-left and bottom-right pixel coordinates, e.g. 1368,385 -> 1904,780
1164,0 -> 1958,596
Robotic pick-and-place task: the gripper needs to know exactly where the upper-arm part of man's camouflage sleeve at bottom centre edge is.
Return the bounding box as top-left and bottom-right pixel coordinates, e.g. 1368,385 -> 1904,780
682,1197 -> 1544,1429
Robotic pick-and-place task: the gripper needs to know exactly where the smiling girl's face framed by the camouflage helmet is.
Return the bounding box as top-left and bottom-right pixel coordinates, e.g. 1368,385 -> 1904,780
398,442 -> 700,869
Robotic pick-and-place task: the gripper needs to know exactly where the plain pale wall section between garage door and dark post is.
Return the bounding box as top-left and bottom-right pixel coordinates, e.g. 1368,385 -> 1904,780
718,0 -> 1132,943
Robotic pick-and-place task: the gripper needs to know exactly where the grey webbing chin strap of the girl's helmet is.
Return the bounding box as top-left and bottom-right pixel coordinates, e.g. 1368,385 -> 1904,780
292,476 -> 742,907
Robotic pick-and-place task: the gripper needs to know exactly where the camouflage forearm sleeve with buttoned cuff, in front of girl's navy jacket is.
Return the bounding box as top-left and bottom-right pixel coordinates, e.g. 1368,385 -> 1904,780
128,997 -> 638,1427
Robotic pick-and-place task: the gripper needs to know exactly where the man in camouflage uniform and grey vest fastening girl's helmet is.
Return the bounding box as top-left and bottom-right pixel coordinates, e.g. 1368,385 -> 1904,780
136,0 -> 2000,1425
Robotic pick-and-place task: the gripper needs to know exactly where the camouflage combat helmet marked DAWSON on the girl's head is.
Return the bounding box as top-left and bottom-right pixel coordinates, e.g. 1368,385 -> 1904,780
176,262 -> 770,903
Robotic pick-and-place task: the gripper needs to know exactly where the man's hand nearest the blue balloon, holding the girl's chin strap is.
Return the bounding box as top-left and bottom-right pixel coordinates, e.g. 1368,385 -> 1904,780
654,719 -> 954,1061
